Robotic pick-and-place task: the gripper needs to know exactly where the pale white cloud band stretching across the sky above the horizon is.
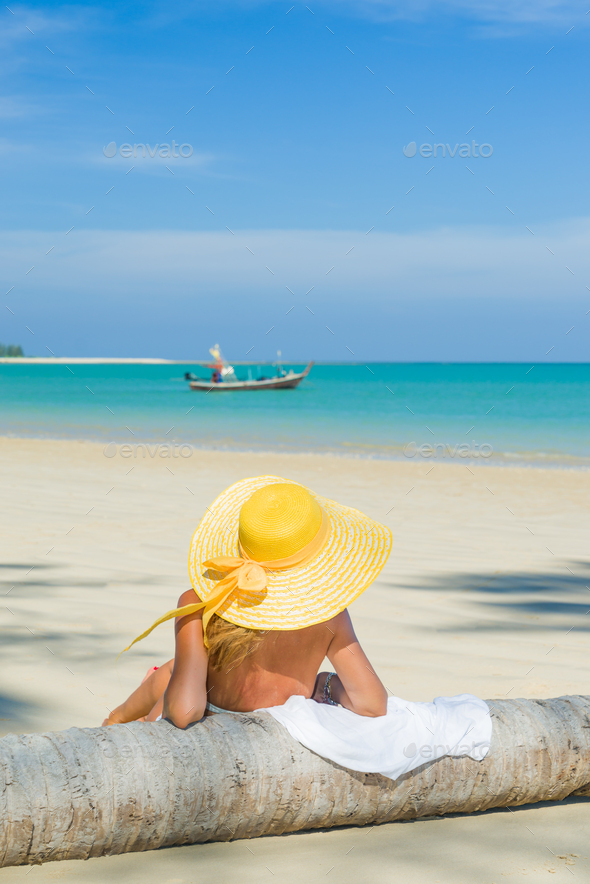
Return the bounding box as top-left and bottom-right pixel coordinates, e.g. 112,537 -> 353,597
0,218 -> 590,305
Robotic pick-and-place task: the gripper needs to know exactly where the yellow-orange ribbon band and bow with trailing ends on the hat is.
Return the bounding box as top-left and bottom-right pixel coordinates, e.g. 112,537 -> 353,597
121,511 -> 330,653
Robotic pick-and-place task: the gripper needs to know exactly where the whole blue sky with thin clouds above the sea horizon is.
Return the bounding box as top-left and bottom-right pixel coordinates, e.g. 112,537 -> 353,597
0,0 -> 590,362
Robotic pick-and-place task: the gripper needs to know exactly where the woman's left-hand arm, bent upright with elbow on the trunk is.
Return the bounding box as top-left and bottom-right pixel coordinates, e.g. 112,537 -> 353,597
163,589 -> 208,728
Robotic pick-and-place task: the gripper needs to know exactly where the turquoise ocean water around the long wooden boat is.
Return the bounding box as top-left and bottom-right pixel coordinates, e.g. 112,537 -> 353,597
0,361 -> 590,466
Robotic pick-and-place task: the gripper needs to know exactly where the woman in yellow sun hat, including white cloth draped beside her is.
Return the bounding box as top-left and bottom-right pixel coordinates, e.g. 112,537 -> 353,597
103,476 -> 491,778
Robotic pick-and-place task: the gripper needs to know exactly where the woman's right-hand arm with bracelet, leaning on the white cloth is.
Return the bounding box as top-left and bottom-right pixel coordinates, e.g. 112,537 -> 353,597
316,610 -> 387,717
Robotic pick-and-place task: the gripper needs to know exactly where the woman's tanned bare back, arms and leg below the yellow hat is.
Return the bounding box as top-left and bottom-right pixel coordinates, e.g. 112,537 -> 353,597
103,612 -> 387,728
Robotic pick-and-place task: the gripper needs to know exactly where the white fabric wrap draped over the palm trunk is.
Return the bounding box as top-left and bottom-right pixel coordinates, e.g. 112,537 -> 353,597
265,694 -> 492,780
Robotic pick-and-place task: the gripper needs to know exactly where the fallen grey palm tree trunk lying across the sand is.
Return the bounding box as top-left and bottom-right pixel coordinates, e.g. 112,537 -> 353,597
0,696 -> 590,866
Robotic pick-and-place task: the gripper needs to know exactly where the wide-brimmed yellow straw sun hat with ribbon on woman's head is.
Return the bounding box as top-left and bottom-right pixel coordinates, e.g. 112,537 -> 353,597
125,476 -> 392,650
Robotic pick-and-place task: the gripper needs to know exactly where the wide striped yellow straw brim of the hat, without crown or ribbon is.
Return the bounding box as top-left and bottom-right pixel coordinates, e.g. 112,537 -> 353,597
188,476 -> 392,630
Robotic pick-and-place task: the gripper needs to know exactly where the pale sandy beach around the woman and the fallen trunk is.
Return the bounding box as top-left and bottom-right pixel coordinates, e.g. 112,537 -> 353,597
0,438 -> 590,884
